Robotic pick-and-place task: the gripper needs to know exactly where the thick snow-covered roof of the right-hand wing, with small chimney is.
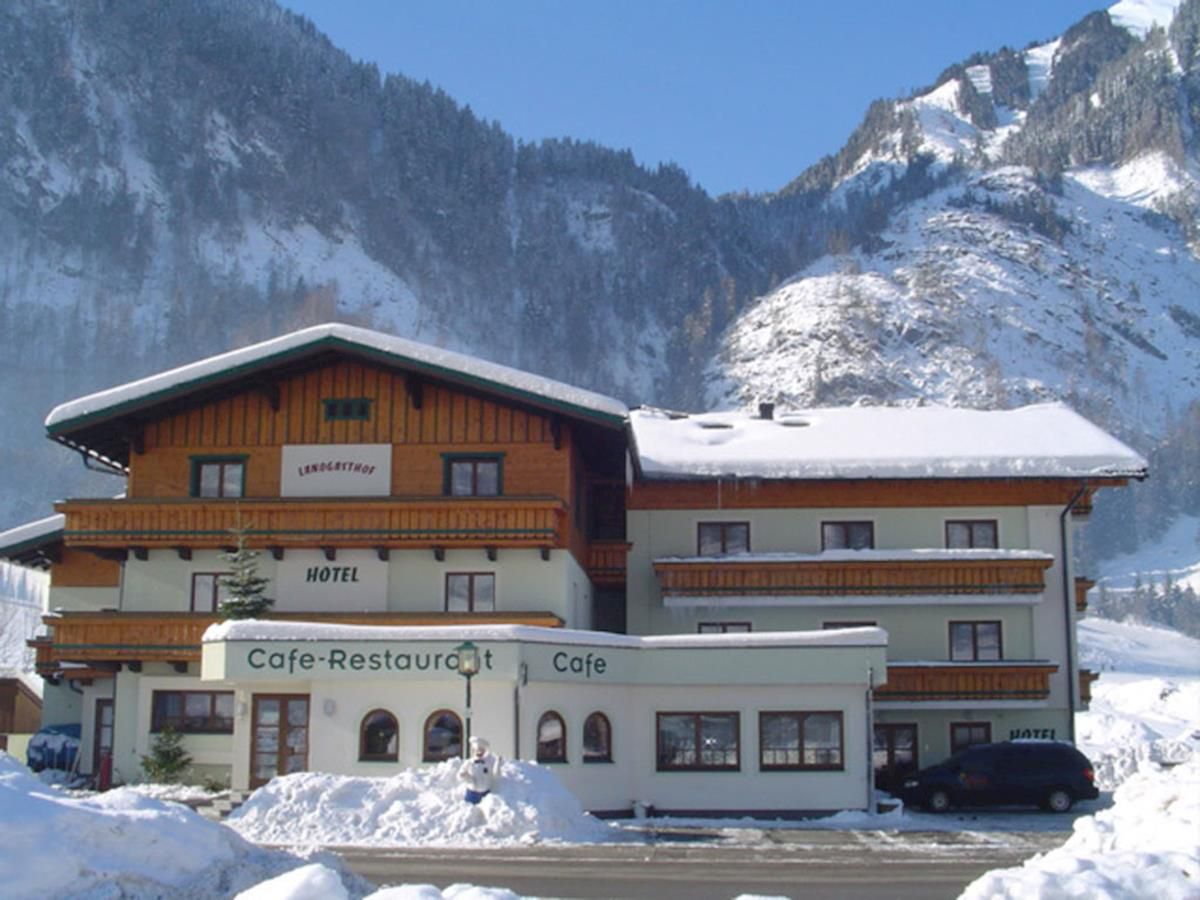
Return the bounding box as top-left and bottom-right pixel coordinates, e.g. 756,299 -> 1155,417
630,403 -> 1146,479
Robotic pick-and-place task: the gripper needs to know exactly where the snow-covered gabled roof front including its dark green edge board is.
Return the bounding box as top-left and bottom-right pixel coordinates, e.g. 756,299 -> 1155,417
46,323 -> 628,434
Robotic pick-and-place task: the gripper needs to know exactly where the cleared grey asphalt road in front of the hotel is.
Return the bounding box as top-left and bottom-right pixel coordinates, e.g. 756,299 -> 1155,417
337,830 -> 1069,900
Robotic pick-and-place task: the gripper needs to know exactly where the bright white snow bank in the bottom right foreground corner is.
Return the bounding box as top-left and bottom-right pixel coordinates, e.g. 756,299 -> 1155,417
960,761 -> 1200,900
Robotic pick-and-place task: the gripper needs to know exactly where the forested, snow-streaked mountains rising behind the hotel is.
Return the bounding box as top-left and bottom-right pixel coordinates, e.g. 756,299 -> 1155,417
0,0 -> 1200,573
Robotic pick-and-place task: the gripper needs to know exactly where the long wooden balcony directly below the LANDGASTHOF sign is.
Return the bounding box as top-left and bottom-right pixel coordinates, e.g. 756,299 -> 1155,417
56,497 -> 566,551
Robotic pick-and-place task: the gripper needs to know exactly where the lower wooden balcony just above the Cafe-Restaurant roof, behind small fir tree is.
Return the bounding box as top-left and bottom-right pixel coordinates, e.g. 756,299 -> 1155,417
30,612 -> 563,678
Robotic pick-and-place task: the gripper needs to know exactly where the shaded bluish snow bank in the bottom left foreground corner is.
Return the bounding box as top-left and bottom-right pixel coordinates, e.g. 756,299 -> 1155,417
0,751 -> 364,900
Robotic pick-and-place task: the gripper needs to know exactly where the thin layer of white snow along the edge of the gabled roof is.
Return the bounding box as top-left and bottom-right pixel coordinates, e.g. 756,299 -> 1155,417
44,323 -> 629,433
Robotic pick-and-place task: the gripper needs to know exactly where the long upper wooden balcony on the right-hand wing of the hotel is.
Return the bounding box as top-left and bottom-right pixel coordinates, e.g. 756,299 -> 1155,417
654,556 -> 1054,601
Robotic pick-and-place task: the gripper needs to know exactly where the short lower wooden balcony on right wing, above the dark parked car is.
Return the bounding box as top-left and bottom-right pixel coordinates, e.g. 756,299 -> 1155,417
875,660 -> 1058,702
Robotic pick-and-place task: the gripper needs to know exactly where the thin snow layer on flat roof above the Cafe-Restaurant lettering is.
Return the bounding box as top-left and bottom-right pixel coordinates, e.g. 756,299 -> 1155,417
204,619 -> 888,649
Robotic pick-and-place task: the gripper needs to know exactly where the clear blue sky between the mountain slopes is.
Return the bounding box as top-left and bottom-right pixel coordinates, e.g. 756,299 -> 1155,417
281,0 -> 1104,194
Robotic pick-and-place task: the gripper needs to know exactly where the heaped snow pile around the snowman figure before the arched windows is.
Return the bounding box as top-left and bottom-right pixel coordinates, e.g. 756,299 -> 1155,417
227,760 -> 620,846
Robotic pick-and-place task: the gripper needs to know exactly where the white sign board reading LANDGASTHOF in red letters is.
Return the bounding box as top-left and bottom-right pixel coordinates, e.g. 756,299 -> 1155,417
280,444 -> 391,497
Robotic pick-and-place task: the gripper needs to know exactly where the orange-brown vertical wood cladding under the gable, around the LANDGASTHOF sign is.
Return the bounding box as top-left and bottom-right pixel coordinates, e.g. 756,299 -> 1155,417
128,361 -> 572,499
